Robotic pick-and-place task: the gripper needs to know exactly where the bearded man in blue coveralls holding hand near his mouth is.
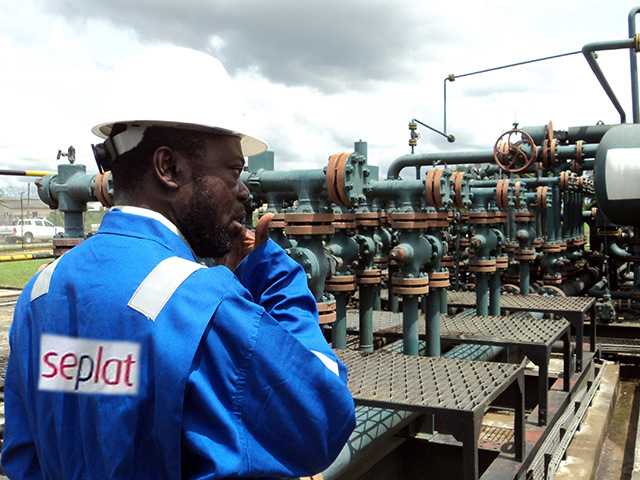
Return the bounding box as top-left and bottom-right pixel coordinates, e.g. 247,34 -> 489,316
2,63 -> 355,479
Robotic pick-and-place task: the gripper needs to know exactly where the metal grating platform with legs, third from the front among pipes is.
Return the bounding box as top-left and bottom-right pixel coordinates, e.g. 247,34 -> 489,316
447,291 -> 596,372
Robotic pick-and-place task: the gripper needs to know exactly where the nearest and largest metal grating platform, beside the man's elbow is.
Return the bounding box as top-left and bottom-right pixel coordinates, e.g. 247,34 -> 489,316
335,350 -> 524,479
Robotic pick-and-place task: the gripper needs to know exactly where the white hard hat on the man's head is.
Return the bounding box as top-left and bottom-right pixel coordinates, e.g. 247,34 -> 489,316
91,46 -> 267,156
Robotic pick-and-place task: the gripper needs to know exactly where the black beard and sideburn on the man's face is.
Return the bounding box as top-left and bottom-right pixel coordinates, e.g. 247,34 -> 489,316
177,175 -> 233,258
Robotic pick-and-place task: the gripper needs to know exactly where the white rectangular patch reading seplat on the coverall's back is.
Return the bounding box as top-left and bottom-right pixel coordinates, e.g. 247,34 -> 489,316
38,334 -> 140,395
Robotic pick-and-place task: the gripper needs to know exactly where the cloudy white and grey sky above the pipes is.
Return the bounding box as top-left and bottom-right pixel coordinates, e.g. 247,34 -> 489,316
0,0 -> 640,193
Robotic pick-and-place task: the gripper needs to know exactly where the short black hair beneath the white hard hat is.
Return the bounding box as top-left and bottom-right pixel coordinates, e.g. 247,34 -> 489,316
111,125 -> 211,194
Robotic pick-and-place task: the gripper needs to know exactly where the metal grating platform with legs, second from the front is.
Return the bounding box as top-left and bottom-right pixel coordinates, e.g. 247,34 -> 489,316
347,311 -> 571,425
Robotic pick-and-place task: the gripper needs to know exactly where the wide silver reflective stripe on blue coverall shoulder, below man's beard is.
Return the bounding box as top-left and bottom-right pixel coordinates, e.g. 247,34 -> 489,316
127,257 -> 205,321
